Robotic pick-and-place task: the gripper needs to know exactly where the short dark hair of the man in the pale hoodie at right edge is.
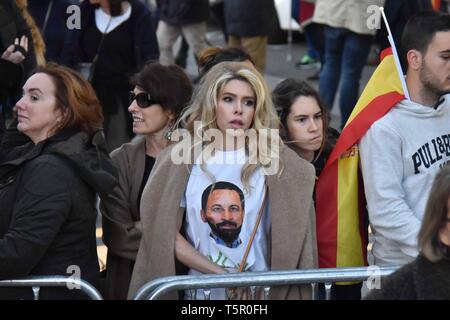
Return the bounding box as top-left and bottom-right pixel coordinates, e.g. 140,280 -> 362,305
401,10 -> 450,71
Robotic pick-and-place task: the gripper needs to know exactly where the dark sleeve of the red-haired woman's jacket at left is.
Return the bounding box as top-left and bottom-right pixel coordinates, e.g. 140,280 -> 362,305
0,156 -> 73,278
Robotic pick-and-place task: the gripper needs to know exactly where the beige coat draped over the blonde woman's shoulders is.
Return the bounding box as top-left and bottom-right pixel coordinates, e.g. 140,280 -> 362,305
128,146 -> 317,299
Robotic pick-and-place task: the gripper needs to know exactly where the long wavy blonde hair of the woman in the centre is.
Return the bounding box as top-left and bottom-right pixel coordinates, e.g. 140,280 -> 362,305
177,62 -> 283,190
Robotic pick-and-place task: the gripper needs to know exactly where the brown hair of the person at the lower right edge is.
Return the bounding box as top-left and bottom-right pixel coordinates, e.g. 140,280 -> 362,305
418,165 -> 450,262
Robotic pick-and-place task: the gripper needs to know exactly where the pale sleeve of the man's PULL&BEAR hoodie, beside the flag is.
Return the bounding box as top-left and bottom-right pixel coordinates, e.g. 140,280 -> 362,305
359,123 -> 421,257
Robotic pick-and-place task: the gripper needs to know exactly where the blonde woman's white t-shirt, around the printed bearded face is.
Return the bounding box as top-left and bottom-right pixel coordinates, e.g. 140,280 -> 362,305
181,149 -> 270,299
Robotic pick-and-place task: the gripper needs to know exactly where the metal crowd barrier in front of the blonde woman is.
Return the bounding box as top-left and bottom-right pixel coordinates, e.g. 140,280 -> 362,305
133,266 -> 399,300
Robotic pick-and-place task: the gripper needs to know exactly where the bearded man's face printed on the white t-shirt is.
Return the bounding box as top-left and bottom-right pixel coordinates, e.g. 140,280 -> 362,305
201,189 -> 244,245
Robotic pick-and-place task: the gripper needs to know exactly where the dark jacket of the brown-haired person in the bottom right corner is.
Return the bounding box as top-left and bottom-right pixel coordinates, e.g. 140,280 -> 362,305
366,255 -> 450,300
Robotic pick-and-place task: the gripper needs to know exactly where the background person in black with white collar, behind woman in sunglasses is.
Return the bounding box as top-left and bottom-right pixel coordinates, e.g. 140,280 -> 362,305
72,0 -> 159,150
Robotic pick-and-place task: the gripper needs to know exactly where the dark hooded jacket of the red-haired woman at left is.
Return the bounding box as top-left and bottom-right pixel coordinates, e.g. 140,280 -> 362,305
0,130 -> 117,299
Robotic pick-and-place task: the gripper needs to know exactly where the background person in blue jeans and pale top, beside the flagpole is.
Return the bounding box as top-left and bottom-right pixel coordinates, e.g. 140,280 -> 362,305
313,0 -> 384,129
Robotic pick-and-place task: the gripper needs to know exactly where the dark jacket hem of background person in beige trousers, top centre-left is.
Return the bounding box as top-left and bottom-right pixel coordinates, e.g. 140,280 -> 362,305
156,0 -> 209,26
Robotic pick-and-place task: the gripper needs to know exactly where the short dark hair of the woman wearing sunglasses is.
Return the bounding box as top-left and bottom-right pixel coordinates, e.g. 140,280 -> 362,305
131,61 -> 192,118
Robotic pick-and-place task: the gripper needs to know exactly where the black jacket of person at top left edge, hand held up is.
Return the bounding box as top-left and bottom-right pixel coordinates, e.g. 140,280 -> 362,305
0,0 -> 36,137
